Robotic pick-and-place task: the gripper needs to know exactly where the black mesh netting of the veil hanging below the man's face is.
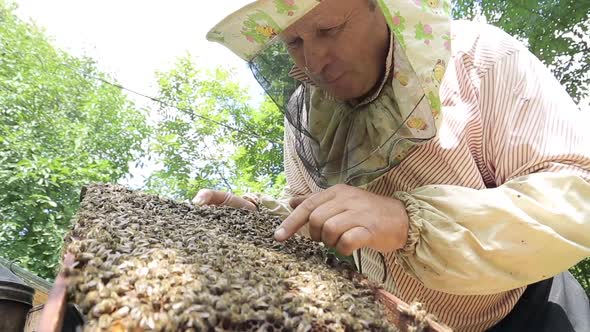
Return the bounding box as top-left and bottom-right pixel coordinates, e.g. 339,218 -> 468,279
250,39 -> 432,188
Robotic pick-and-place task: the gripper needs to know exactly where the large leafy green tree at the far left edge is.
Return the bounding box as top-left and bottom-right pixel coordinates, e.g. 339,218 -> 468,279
0,0 -> 148,278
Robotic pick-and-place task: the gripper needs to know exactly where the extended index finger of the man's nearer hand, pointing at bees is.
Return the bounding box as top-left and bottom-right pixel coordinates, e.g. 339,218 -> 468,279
275,190 -> 335,242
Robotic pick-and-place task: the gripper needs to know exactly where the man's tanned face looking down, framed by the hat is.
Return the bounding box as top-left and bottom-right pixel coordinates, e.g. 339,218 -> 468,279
281,0 -> 389,100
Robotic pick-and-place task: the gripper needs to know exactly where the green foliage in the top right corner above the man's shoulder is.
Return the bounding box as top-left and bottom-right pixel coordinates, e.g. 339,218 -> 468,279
454,0 -> 590,103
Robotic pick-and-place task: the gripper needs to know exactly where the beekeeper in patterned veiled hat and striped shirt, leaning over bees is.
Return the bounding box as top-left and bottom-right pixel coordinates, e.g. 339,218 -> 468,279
194,0 -> 590,331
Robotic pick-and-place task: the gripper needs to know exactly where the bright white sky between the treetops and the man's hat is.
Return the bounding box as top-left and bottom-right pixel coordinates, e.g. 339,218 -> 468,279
13,0 -> 260,98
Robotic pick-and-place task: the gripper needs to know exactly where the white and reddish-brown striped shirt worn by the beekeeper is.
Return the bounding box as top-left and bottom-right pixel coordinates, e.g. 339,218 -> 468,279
285,22 -> 590,331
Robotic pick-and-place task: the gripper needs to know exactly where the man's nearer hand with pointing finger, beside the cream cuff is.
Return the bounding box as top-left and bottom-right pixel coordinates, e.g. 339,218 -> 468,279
275,185 -> 409,256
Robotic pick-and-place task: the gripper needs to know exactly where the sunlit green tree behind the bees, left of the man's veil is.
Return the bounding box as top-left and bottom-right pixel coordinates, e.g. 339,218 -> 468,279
146,56 -> 285,199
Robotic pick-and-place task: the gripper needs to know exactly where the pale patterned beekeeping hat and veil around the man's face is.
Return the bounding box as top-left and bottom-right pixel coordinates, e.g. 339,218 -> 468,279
207,0 -> 450,188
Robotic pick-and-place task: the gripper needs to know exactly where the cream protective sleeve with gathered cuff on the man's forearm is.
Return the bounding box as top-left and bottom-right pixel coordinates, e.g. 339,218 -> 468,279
396,173 -> 590,294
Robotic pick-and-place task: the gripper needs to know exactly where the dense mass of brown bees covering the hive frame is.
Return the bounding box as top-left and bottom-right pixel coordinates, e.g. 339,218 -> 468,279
65,185 -> 397,331
